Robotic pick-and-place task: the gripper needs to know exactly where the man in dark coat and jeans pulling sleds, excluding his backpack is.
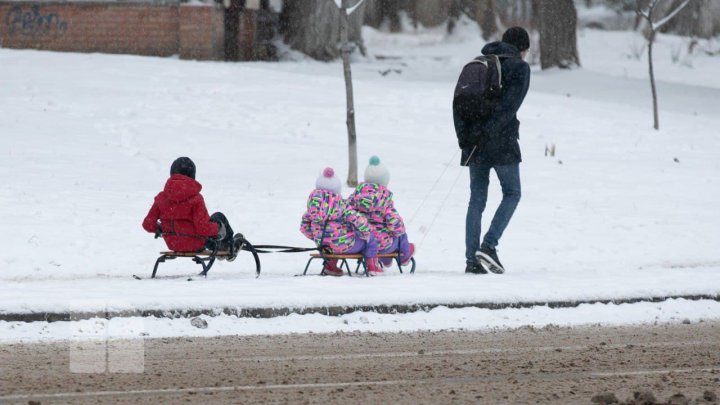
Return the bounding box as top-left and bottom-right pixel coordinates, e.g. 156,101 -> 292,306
454,27 -> 530,274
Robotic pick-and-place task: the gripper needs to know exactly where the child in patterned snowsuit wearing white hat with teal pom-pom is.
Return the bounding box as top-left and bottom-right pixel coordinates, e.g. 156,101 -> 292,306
348,156 -> 415,267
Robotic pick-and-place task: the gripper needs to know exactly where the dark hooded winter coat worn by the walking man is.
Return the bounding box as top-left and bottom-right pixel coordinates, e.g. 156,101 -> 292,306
454,42 -> 530,166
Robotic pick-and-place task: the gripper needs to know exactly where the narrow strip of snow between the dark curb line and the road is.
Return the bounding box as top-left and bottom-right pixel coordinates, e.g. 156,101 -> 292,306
0,299 -> 720,344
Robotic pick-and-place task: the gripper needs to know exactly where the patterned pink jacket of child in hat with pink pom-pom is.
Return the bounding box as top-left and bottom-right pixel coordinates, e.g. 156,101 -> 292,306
300,189 -> 371,253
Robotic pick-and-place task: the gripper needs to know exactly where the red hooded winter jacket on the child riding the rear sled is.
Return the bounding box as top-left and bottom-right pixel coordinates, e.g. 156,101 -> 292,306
143,174 -> 218,252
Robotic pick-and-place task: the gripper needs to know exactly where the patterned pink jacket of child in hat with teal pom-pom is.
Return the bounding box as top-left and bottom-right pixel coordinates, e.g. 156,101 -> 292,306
348,183 -> 405,252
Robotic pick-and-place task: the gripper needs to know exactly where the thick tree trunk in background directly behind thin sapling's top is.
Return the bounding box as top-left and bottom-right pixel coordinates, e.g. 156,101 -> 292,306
280,0 -> 365,61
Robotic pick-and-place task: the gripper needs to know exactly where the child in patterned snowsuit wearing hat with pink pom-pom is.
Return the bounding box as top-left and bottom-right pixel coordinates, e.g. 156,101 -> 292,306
300,167 -> 382,276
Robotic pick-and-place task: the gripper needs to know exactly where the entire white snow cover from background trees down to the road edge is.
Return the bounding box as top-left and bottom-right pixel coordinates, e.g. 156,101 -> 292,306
0,19 -> 720,342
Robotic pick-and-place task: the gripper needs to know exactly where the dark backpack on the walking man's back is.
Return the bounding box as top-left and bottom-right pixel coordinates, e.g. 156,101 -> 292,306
453,55 -> 502,124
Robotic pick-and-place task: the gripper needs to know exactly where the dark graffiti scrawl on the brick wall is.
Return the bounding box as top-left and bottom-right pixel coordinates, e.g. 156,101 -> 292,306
5,5 -> 68,36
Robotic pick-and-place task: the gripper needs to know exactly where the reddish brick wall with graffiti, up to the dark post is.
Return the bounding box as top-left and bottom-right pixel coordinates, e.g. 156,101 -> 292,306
0,0 -> 224,59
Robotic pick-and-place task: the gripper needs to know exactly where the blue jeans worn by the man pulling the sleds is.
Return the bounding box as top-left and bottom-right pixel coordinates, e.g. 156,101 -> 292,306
465,163 -> 520,263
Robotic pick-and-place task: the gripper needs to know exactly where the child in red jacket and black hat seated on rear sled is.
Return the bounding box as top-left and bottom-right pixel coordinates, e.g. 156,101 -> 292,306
143,157 -> 242,261
